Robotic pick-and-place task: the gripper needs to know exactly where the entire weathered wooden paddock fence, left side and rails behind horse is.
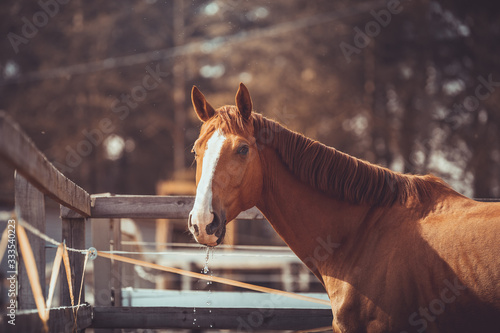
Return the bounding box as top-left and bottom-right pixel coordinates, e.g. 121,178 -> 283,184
0,112 -> 332,332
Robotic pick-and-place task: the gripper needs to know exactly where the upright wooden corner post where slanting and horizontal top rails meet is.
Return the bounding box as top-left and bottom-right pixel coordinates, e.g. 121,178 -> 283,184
60,218 -> 85,306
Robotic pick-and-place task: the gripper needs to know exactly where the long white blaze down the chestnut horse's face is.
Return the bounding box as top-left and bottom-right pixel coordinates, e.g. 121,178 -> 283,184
191,131 -> 226,225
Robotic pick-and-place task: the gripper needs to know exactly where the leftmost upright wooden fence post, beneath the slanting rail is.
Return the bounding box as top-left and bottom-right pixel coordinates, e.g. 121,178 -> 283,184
15,172 -> 45,309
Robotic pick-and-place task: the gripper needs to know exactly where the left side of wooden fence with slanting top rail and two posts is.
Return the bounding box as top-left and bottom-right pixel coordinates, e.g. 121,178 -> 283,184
0,113 -> 92,332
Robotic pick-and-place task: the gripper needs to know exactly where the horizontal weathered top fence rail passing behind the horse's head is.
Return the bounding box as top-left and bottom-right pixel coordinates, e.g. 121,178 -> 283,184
61,195 -> 264,220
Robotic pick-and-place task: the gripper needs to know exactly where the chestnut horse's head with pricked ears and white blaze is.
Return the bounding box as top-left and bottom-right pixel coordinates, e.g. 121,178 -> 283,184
188,83 -> 263,246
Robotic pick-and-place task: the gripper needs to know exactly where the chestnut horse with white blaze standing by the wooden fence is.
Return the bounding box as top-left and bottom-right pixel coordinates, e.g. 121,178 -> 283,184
188,83 -> 500,333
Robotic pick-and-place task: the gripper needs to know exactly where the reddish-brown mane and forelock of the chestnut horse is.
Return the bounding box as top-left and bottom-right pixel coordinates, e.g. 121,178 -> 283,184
205,106 -> 447,206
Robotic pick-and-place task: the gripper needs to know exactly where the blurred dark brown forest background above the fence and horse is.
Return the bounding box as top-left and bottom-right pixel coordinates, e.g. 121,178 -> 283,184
0,0 -> 500,198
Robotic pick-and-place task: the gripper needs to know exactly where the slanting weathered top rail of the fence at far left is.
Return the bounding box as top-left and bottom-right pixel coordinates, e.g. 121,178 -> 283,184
0,111 -> 90,216
